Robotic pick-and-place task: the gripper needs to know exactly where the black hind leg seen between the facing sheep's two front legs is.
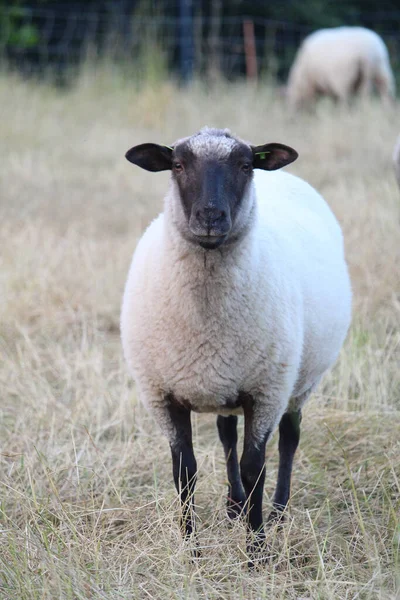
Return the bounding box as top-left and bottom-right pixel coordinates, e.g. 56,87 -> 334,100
217,415 -> 246,519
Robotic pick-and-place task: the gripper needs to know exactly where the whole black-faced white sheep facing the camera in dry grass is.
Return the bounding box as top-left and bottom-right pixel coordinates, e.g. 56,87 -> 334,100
121,128 -> 351,565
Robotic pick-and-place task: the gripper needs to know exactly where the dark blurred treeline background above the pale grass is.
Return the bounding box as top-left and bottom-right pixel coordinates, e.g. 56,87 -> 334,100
0,0 -> 400,82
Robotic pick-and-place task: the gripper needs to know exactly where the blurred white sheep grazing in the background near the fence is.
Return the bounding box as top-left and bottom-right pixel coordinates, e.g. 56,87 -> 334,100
287,27 -> 395,109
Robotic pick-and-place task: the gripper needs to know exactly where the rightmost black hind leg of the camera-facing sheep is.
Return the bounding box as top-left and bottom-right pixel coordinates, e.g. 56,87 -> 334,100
268,410 -> 301,521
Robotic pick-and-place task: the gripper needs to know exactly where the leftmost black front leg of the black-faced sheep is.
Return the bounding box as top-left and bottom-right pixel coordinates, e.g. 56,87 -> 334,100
168,398 -> 197,537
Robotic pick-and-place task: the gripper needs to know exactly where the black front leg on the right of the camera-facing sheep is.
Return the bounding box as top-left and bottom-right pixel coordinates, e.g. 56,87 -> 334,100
240,397 -> 271,564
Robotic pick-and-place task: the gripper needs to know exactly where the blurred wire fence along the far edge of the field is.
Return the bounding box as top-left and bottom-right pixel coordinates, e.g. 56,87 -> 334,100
0,1 -> 400,80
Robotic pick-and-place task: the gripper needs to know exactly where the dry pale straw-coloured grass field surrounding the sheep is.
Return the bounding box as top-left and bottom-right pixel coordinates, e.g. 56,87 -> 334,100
0,71 -> 400,600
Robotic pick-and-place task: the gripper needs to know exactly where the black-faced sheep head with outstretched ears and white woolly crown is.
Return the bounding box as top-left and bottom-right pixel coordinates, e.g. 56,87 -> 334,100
126,128 -> 298,250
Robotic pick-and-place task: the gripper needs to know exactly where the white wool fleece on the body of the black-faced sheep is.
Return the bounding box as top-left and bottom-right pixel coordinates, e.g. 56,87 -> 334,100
121,151 -> 351,440
